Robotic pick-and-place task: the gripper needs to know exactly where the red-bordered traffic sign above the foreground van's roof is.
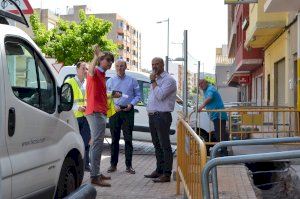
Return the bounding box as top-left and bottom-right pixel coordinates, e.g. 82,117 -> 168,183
0,0 -> 33,14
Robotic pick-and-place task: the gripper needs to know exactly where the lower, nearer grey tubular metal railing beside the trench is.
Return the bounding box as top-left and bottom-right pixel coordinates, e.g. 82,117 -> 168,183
202,150 -> 300,199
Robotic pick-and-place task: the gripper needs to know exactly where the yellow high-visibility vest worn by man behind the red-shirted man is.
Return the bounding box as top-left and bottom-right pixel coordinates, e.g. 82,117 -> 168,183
66,77 -> 85,118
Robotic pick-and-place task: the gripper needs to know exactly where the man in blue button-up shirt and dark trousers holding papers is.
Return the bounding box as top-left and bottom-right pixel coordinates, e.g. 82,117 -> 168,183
106,60 -> 141,174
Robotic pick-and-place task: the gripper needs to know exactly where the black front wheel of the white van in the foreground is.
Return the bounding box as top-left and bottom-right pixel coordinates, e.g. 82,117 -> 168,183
55,157 -> 77,198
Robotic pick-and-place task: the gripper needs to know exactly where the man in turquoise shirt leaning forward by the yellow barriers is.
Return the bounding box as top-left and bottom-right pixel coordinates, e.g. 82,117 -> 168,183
198,79 -> 229,155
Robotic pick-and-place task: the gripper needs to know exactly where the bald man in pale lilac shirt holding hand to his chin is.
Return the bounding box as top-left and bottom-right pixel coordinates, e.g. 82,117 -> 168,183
145,57 -> 177,183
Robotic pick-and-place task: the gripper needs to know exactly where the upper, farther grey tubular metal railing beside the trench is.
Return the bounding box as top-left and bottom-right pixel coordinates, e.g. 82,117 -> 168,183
210,137 -> 300,199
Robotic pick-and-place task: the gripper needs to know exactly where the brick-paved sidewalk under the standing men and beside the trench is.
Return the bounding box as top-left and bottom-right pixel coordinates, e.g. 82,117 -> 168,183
83,141 -> 256,199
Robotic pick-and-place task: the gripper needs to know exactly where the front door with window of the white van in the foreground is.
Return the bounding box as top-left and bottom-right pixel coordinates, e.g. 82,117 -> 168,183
3,37 -> 58,198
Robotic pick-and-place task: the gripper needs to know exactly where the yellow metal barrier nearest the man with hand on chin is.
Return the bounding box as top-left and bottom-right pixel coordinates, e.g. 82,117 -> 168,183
176,119 -> 207,199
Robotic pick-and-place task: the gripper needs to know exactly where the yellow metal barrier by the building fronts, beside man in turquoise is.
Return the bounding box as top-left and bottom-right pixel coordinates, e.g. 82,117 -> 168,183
196,107 -> 300,145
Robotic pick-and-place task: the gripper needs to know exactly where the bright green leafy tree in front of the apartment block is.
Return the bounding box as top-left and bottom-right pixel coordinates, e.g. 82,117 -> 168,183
30,10 -> 118,65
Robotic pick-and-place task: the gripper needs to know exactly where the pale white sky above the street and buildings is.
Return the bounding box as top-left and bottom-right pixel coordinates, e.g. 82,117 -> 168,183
29,0 -> 227,73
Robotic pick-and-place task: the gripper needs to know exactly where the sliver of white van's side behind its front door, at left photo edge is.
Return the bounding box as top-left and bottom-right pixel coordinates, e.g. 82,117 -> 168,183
0,42 -> 12,198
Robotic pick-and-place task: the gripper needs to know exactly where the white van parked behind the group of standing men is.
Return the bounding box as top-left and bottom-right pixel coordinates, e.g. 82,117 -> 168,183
57,66 -> 212,143
